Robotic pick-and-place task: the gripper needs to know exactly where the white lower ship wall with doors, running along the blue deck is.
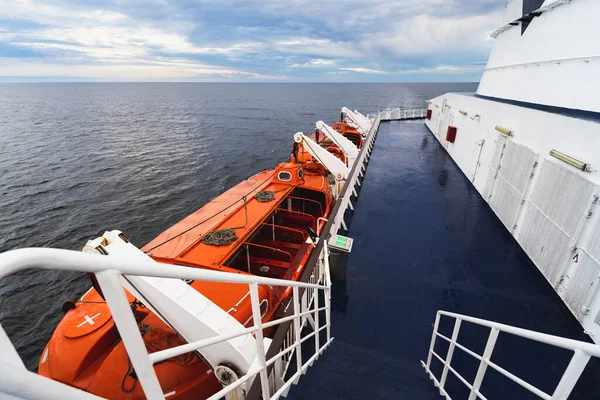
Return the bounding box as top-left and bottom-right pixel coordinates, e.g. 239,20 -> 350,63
426,93 -> 600,342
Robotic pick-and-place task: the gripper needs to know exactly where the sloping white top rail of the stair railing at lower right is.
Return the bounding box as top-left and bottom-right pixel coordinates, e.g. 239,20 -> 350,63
438,310 -> 600,357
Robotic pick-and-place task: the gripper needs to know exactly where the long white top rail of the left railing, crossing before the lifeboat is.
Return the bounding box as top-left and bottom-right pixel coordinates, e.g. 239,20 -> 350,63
0,248 -> 324,289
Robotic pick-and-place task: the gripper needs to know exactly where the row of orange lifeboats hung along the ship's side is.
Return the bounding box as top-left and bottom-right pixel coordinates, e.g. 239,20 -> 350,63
38,115 -> 362,399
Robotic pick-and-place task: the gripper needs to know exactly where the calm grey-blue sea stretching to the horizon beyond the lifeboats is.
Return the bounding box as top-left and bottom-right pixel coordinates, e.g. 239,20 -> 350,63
0,83 -> 477,370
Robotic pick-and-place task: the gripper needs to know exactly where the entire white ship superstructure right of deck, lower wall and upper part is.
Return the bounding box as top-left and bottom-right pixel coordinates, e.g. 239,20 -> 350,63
426,0 -> 600,343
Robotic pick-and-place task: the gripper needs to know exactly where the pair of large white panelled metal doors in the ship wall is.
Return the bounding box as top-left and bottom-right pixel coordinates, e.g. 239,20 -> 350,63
484,135 -> 600,324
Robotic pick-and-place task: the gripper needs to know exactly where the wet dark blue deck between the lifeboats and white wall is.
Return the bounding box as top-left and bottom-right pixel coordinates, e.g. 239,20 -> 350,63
288,121 -> 600,400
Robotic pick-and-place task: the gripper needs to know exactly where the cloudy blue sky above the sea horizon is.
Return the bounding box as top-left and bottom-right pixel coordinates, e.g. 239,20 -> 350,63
0,0 -> 504,82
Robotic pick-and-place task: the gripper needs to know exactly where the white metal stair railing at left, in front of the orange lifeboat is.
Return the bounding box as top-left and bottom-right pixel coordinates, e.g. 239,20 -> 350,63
0,248 -> 333,399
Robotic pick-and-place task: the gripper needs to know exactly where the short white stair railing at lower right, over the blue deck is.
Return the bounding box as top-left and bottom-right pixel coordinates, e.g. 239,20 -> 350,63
421,311 -> 600,400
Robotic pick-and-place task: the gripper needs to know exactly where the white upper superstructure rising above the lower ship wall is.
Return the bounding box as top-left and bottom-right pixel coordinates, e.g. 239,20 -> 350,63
477,0 -> 600,112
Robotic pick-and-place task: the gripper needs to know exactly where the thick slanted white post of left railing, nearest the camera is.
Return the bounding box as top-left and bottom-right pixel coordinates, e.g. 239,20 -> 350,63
96,270 -> 165,400
